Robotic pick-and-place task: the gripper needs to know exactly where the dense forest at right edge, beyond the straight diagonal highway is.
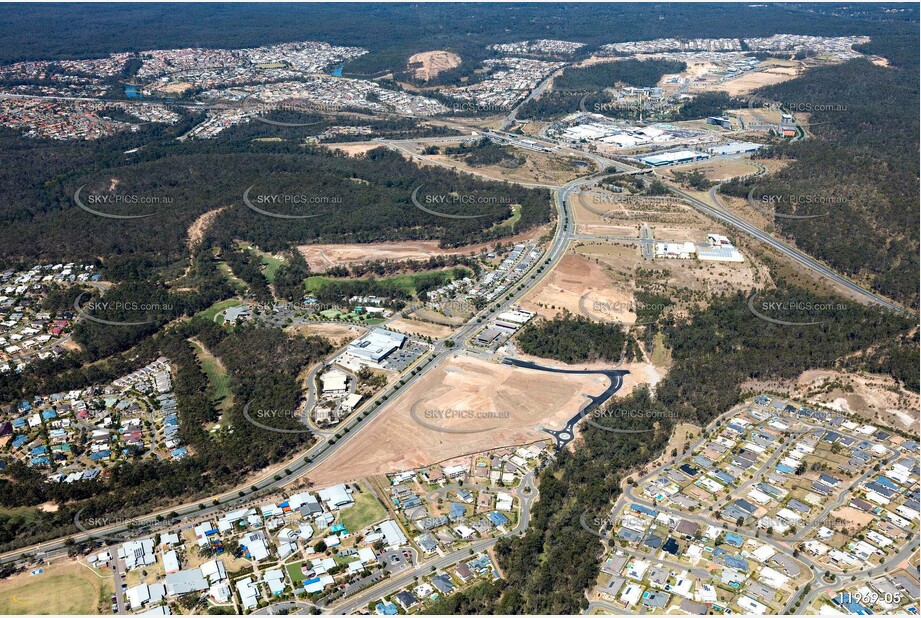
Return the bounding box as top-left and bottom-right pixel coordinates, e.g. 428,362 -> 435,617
721,38 -> 921,310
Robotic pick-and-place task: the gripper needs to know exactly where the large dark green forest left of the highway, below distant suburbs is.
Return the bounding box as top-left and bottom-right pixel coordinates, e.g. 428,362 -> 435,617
0,123 -> 551,280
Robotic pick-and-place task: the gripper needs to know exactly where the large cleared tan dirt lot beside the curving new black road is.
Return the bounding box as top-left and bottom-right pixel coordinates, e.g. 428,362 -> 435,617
310,355 -> 607,485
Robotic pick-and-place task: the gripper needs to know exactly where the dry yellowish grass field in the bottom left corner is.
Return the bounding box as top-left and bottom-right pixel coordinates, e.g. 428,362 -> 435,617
0,562 -> 113,615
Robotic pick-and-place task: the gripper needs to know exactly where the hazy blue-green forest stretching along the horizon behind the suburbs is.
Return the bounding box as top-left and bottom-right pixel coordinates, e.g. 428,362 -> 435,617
0,3 -> 918,75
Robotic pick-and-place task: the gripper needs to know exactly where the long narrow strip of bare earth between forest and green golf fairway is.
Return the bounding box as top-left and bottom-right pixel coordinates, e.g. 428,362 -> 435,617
298,227 -> 544,274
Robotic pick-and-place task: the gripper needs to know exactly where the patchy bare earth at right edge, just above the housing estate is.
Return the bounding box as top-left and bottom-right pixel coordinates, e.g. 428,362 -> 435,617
744,369 -> 921,433
